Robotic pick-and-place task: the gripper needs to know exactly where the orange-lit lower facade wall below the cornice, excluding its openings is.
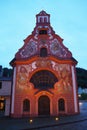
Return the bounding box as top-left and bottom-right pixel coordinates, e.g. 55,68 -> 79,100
11,60 -> 78,117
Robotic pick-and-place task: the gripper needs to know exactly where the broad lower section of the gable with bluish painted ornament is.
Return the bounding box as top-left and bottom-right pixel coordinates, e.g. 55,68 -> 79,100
16,38 -> 72,59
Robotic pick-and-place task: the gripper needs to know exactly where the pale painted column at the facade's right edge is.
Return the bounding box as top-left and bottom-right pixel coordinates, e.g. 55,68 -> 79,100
72,66 -> 78,112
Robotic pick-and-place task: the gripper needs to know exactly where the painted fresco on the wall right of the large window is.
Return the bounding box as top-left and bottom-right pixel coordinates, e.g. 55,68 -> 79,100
54,64 -> 72,93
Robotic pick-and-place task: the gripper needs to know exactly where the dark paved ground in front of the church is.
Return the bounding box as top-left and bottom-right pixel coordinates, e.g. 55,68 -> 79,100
0,102 -> 87,130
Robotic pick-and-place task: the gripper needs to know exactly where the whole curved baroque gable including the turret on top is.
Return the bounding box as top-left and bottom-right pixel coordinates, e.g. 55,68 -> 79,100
15,11 -> 72,60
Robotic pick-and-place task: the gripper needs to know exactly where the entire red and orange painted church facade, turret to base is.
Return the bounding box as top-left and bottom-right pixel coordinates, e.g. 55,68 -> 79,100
10,11 -> 79,117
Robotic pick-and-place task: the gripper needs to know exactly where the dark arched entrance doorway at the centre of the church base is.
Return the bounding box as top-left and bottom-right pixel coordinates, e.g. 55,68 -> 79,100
38,96 -> 50,115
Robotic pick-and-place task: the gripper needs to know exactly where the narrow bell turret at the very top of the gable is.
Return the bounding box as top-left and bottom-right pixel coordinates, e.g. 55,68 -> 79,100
32,10 -> 55,39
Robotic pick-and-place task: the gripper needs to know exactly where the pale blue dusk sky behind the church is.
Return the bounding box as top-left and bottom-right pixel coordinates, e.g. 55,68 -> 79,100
0,0 -> 87,69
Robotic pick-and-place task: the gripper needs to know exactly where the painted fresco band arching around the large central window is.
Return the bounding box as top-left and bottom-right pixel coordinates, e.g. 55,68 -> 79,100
17,58 -> 72,93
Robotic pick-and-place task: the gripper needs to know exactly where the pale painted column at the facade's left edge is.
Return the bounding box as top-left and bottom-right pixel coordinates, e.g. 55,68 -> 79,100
11,67 -> 16,114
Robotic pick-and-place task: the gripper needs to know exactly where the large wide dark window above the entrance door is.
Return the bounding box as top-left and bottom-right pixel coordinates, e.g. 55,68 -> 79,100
30,70 -> 58,90
